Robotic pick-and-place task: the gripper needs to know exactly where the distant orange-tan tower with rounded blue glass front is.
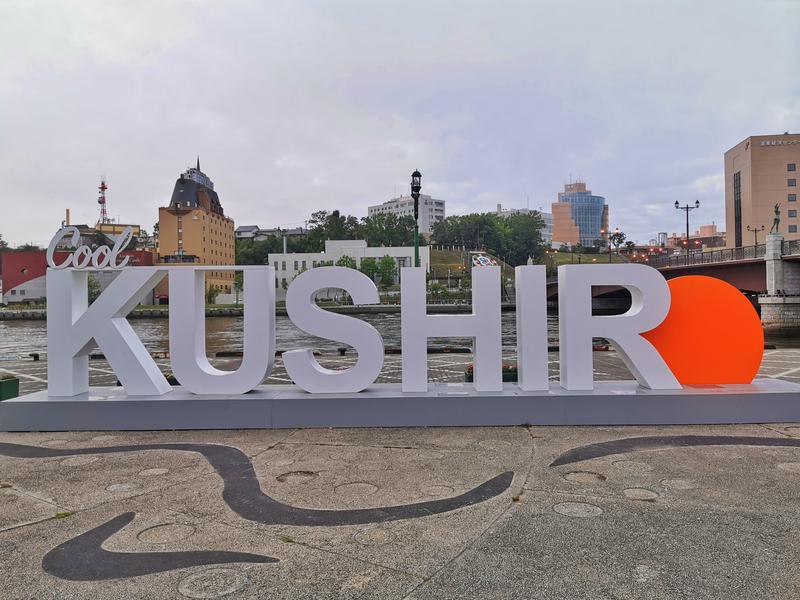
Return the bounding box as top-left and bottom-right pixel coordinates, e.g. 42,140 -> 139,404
552,182 -> 608,248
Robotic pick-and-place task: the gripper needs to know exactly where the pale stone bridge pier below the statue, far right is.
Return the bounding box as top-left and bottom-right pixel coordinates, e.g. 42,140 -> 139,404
758,233 -> 800,334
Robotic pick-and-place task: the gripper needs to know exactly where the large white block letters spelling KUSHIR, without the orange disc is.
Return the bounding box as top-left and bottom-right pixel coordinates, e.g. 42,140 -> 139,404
47,264 -> 681,396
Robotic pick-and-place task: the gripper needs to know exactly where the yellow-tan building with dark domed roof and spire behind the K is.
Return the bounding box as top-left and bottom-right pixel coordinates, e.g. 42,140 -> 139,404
156,160 -> 236,300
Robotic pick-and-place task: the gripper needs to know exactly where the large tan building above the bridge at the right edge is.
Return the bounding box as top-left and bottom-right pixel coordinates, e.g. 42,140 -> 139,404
725,133 -> 800,247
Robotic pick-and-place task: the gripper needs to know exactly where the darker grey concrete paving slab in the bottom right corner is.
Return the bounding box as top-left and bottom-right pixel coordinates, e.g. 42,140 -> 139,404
408,493 -> 800,600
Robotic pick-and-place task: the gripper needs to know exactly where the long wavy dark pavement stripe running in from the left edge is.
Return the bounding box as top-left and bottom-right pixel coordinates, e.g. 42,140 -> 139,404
0,442 -> 514,526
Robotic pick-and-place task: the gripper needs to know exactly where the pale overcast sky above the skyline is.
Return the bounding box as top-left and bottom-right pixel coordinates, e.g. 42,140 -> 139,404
0,0 -> 800,245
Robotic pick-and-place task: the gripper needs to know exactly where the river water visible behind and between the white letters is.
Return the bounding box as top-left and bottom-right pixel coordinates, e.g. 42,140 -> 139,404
0,311 -> 800,357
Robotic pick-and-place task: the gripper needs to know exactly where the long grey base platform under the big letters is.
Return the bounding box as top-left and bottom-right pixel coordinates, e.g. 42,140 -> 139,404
0,379 -> 800,431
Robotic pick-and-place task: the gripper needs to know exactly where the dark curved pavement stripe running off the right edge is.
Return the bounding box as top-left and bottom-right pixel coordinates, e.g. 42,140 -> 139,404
550,435 -> 800,467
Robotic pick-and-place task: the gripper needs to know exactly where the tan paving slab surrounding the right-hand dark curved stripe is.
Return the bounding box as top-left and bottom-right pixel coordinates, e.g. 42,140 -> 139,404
527,426 -> 800,513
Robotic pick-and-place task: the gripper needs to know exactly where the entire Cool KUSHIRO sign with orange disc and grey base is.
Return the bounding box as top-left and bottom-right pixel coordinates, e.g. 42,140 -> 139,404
0,225 -> 800,430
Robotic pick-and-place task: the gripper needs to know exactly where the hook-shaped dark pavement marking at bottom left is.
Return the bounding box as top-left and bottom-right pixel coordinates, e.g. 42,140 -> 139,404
42,512 -> 278,581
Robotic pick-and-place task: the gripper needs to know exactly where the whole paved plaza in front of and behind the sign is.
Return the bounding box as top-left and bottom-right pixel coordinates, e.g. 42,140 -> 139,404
0,349 -> 800,600
